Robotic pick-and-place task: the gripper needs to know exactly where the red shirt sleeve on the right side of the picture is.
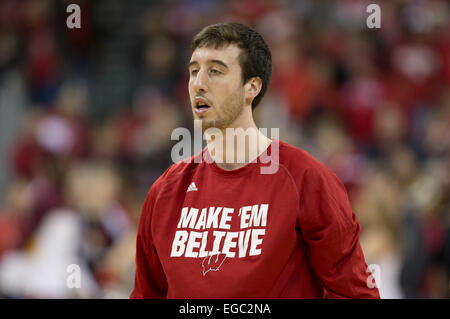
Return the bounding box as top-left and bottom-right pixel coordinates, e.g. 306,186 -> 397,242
299,167 -> 380,299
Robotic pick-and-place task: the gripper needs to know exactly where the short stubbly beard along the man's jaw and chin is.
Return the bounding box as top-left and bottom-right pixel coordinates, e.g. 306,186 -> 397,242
197,88 -> 244,131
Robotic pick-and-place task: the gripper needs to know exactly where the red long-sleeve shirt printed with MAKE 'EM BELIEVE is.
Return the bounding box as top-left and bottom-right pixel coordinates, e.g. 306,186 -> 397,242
130,139 -> 379,298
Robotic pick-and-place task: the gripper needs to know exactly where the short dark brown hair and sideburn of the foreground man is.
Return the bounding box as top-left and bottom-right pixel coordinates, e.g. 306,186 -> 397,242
191,22 -> 272,110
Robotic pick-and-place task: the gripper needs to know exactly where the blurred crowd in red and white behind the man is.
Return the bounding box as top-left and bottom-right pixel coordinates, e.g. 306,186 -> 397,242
0,0 -> 450,298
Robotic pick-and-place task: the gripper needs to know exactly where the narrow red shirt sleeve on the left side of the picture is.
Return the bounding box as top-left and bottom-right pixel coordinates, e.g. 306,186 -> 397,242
130,184 -> 167,299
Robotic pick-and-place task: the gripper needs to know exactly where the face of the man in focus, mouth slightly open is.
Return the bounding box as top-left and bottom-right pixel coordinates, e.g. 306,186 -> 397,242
189,44 -> 244,130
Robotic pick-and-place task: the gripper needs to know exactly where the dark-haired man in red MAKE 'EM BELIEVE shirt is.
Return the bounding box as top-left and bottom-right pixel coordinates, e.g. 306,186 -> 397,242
130,23 -> 379,298
